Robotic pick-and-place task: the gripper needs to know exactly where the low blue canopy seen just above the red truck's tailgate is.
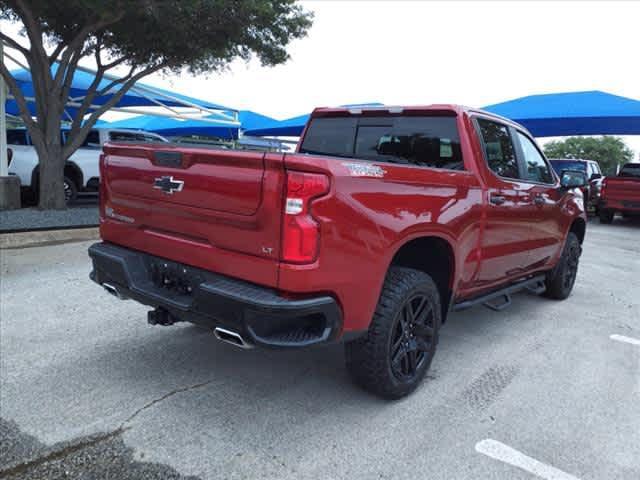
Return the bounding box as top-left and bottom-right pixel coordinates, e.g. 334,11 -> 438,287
109,115 -> 240,139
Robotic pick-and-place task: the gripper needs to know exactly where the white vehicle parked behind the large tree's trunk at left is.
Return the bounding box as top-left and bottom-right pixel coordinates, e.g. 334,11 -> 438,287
7,128 -> 169,203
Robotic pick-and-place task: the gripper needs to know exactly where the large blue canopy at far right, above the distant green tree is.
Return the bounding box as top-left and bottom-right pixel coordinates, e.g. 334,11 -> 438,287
483,90 -> 640,137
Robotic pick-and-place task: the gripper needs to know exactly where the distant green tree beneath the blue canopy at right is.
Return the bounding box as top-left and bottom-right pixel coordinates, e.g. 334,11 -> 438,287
544,135 -> 633,175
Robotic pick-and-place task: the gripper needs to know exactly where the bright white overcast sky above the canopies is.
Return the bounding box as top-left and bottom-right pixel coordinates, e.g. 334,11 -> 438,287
1,0 -> 640,155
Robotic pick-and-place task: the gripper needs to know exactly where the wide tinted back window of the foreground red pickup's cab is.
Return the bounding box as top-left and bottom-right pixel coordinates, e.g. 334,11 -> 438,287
300,116 -> 464,170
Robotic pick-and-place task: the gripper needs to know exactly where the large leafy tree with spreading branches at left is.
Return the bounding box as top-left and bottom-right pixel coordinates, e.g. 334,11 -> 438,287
0,0 -> 312,209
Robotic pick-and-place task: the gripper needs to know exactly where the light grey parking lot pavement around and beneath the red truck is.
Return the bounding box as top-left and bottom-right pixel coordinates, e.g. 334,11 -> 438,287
0,219 -> 640,480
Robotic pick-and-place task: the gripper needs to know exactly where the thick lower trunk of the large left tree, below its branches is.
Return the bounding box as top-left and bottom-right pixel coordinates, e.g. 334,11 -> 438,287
38,142 -> 67,210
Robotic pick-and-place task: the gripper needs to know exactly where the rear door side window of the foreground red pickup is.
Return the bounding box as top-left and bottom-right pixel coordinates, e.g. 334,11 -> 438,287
478,118 -> 520,179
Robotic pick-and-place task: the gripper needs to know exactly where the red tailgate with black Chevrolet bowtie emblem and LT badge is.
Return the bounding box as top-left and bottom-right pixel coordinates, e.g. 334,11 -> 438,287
100,145 -> 284,286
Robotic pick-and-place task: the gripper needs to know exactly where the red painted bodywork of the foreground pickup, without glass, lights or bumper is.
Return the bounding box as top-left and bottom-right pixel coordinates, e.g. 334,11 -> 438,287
100,105 -> 585,338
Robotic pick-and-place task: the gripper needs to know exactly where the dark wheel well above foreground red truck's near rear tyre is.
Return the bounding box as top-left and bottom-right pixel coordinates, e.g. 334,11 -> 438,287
390,235 -> 456,322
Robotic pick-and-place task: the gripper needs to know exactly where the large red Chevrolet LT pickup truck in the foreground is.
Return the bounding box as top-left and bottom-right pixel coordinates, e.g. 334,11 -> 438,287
89,105 -> 586,398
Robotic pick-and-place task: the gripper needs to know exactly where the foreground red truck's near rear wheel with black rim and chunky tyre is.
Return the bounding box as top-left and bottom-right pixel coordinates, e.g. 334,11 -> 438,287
345,267 -> 442,399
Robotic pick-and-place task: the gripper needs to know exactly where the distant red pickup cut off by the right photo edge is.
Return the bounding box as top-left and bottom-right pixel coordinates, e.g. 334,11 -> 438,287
598,163 -> 640,223
